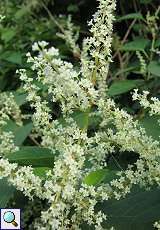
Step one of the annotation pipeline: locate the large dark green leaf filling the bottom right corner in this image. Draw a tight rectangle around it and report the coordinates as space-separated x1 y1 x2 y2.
103 189 160 230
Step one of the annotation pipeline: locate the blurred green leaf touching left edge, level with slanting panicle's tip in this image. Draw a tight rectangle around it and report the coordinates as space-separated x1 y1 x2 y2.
0 51 22 65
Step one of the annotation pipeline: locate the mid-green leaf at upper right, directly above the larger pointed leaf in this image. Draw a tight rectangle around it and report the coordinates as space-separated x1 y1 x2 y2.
121 38 150 51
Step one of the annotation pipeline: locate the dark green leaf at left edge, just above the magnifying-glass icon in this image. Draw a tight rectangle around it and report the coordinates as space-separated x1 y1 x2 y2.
0 179 15 208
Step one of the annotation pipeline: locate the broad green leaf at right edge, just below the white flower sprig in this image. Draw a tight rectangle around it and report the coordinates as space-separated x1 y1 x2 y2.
139 115 160 140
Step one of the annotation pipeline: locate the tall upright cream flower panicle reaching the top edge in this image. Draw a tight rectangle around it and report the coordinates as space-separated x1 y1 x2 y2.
81 0 116 97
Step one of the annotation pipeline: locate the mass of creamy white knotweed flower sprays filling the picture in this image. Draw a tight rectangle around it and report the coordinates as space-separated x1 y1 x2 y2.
0 0 160 230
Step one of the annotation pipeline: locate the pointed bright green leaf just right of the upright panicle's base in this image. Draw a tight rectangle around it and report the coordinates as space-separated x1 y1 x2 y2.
108 80 144 96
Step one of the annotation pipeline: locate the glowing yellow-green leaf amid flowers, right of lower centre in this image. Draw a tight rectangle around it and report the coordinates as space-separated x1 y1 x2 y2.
83 169 116 185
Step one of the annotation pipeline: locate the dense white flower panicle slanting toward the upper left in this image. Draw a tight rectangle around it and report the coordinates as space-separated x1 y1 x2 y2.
21 43 97 113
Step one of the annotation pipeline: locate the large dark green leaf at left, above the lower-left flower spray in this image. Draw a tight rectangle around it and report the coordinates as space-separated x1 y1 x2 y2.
6 146 55 167
